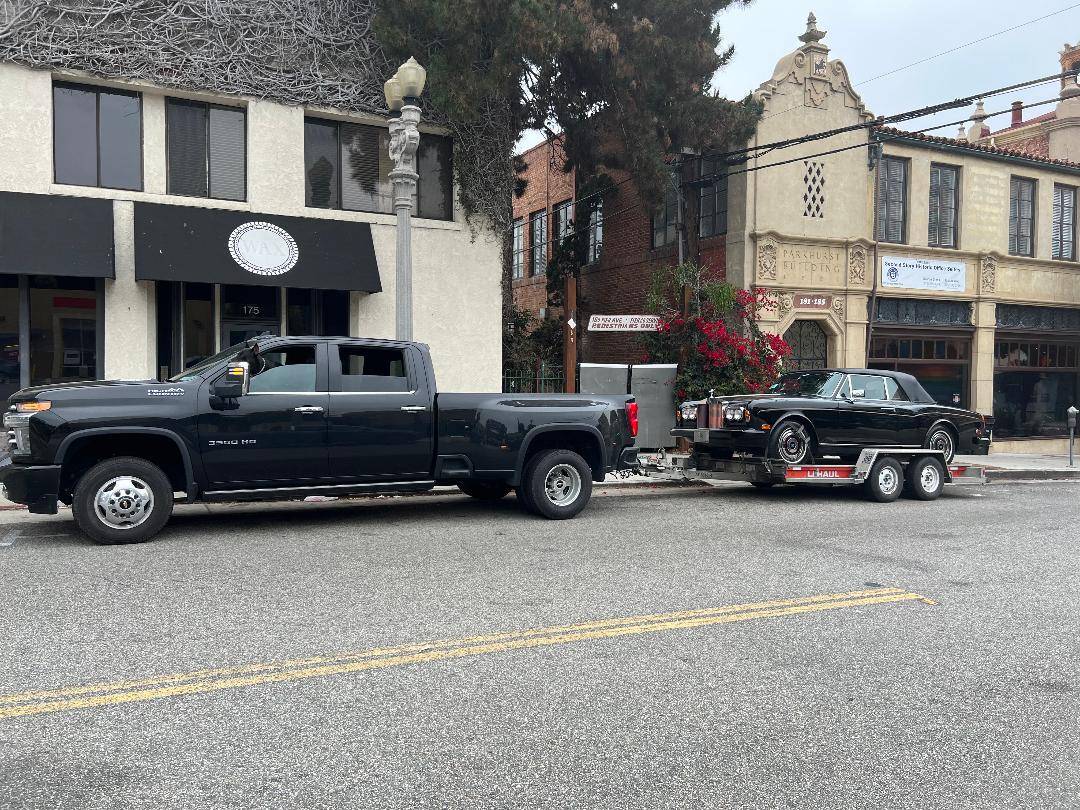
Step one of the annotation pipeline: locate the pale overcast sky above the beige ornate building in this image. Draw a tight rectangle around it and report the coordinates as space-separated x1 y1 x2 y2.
521 0 1080 148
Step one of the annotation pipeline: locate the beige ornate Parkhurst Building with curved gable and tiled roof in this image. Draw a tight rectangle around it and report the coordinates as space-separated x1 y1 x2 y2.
727 15 1080 451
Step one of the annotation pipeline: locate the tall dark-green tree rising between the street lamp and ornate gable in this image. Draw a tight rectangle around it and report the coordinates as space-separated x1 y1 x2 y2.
375 0 760 330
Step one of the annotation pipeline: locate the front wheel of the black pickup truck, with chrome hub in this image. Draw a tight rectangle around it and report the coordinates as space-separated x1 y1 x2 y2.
71 456 173 544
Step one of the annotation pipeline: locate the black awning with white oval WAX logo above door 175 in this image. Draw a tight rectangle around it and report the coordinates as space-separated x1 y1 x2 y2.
135 203 382 293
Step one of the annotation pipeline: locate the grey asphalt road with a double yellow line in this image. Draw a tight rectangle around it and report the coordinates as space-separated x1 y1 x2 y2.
0 483 1080 809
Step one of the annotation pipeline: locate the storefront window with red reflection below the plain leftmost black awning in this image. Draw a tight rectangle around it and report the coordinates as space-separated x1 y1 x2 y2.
29 275 100 386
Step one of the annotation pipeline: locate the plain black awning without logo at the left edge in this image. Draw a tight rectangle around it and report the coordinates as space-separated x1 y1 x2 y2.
0 192 113 279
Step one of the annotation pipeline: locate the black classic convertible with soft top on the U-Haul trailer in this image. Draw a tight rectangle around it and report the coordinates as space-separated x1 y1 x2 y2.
672 368 990 464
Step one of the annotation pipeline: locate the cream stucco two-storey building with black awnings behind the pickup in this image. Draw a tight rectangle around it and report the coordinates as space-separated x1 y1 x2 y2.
0 26 501 406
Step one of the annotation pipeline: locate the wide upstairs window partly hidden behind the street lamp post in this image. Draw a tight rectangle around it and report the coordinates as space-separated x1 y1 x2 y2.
303 118 454 219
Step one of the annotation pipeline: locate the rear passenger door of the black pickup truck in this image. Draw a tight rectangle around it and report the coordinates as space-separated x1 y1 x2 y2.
327 341 435 483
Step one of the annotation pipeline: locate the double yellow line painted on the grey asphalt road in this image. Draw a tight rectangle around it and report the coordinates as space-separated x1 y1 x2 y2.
0 588 934 719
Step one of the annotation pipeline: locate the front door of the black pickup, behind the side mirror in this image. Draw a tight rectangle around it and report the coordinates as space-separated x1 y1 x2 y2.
199 342 329 489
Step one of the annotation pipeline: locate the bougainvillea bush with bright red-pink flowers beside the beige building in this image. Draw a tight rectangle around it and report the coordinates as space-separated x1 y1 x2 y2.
642 262 791 400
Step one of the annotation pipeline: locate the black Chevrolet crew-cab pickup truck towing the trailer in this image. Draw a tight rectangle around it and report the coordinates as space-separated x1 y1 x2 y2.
0 337 637 543
